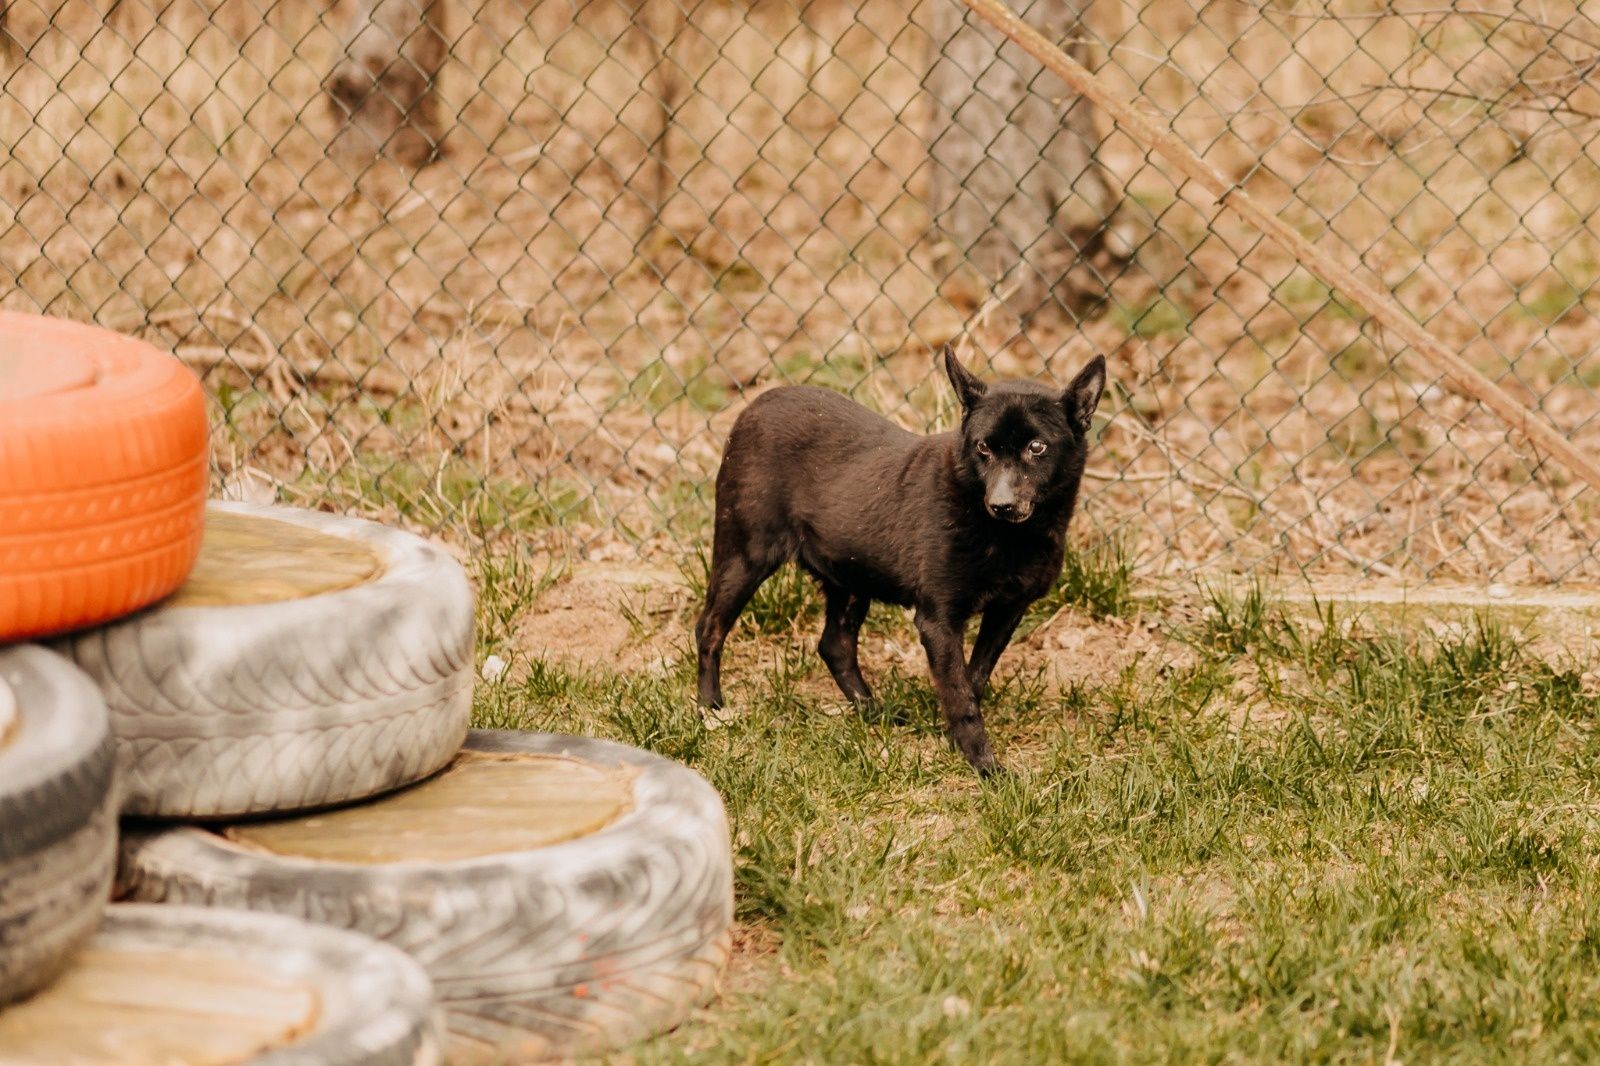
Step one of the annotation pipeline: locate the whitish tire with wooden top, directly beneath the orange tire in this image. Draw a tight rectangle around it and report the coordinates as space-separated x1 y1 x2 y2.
59 504 474 818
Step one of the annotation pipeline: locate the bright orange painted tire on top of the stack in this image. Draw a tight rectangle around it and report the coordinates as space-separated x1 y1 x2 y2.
0 312 208 642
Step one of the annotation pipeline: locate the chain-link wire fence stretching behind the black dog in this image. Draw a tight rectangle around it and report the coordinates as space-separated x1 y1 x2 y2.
0 0 1600 584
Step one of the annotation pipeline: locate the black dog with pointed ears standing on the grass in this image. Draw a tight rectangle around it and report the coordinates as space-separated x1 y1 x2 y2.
694 347 1106 775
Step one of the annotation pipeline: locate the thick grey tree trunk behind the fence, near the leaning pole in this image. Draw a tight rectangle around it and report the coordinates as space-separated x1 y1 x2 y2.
926 0 1118 315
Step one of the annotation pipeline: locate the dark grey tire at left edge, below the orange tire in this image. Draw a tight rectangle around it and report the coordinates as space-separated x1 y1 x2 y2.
0 645 117 1005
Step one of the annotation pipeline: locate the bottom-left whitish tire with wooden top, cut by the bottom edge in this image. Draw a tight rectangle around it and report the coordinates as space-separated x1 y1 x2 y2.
0 904 442 1066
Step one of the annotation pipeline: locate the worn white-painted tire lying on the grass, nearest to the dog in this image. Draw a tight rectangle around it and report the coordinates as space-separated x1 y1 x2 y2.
122 730 733 1063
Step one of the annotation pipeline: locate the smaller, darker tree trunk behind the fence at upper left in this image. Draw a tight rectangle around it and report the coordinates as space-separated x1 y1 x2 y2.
328 0 450 166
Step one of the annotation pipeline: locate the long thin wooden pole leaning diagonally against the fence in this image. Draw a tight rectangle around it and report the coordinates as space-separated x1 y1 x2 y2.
952 0 1600 490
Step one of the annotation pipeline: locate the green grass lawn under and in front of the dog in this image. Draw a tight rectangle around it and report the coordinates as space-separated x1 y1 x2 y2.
477 567 1600 1063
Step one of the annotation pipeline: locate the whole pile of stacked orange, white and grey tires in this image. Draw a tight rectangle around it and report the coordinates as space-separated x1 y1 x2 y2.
0 314 733 1064
